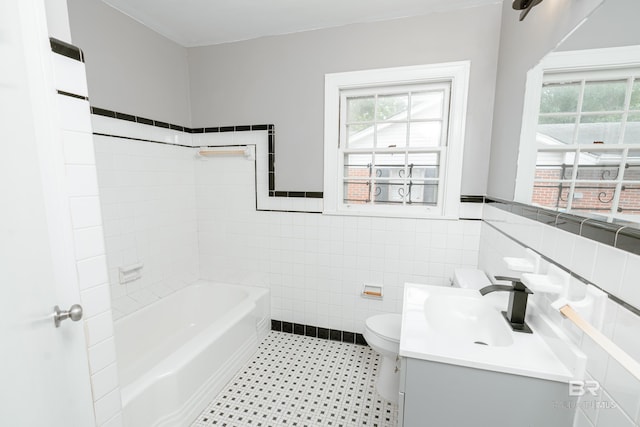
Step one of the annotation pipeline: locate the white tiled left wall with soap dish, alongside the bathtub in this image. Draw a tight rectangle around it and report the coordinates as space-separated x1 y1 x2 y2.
94 135 198 319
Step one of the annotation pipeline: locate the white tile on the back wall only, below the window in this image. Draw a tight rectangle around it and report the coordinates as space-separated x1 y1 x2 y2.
195 157 480 332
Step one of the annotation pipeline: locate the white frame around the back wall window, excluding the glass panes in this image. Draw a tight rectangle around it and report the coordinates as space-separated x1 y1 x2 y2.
323 61 471 219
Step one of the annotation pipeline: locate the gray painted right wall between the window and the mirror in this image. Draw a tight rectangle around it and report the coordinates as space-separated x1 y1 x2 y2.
487 0 604 200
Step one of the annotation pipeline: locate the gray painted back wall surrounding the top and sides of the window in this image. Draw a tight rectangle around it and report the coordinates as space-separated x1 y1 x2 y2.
188 0 501 194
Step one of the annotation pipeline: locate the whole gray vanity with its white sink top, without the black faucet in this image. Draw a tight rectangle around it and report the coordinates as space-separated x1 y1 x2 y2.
399 283 586 427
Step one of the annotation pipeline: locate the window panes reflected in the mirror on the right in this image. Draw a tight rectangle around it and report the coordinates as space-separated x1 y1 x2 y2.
530 53 640 220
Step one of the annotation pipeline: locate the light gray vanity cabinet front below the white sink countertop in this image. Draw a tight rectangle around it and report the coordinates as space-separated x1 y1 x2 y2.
398 357 577 427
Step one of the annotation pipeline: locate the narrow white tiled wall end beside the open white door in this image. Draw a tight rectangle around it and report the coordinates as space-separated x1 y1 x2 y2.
52 54 122 427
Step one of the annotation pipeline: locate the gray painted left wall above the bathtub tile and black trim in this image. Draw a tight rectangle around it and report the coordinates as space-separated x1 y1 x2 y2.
68 0 191 126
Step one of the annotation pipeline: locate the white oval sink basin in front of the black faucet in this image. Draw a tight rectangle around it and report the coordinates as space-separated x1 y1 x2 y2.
424 295 513 346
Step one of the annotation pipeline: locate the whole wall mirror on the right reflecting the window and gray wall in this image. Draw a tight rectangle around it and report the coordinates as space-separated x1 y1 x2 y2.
515 0 640 223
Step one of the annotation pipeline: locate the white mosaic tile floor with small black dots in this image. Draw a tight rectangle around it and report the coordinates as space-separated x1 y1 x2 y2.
191 331 398 427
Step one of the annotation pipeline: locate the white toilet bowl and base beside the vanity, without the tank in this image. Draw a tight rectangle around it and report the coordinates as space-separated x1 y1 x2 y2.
363 314 402 403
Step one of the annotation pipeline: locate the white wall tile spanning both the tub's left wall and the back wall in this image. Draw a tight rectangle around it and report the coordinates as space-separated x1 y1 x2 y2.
93 115 480 332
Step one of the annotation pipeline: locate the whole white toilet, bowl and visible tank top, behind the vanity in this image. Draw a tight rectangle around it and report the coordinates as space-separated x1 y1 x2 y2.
363 268 491 403
